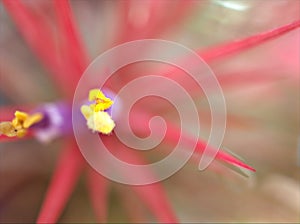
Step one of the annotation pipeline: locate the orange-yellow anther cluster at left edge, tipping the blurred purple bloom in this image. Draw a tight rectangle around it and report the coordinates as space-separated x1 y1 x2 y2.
0 111 43 138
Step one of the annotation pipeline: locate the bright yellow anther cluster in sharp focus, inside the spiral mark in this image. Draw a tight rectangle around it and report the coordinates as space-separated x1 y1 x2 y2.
80 89 115 134
